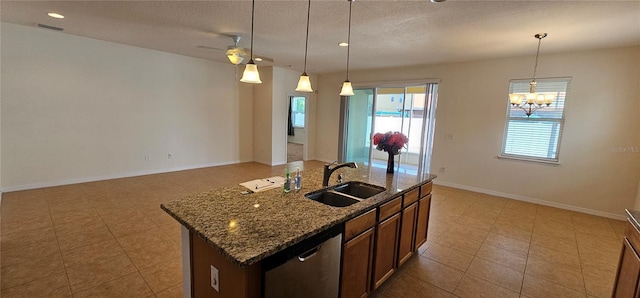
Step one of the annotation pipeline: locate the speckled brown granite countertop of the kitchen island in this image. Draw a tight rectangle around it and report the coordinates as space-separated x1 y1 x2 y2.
161 164 436 267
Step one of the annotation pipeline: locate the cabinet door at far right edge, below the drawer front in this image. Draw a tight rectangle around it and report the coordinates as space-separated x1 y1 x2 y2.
613 238 640 298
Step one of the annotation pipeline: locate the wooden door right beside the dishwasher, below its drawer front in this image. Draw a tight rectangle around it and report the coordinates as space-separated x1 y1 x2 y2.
340 228 374 298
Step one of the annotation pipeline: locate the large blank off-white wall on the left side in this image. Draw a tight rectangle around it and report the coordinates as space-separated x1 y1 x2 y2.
0 23 253 191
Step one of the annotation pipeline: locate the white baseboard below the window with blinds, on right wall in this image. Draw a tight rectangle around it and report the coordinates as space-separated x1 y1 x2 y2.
433 179 627 220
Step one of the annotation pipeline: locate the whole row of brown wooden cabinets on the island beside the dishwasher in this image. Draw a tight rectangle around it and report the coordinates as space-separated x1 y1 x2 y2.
340 182 431 298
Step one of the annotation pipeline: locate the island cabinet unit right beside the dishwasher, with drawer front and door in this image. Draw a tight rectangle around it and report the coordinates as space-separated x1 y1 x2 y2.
340 209 376 298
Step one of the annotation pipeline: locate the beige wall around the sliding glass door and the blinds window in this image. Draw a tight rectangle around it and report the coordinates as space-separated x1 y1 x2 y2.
316 48 640 216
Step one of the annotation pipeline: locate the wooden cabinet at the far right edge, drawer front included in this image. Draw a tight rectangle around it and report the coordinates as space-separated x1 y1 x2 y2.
612 222 640 298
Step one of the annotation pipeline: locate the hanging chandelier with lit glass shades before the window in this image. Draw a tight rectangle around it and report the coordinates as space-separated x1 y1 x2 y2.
509 33 555 118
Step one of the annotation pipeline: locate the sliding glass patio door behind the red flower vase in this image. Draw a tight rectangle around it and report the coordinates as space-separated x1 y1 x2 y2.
339 83 438 175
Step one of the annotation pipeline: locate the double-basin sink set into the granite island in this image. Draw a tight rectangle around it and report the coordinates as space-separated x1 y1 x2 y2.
305 181 386 207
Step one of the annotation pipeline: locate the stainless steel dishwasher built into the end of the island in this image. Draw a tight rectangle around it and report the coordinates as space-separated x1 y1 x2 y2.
263 227 342 298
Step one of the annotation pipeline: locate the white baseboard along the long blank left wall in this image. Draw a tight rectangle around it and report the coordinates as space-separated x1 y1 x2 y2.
2 160 252 192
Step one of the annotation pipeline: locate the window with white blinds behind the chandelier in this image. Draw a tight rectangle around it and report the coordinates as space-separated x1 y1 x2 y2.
501 78 571 162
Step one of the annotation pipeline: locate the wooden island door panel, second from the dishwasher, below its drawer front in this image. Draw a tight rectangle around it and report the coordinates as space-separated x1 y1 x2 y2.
373 213 400 290
